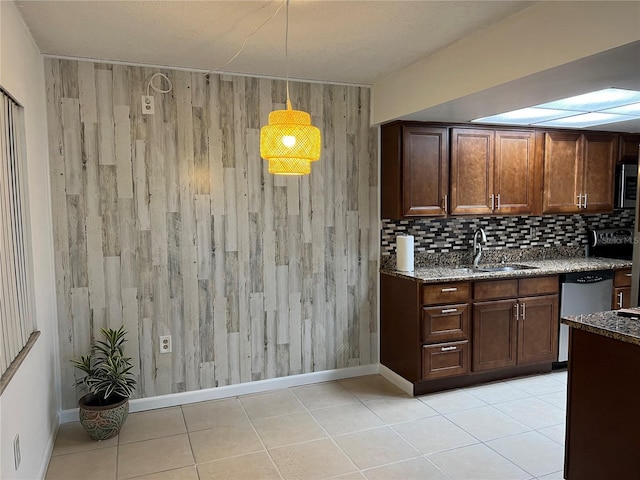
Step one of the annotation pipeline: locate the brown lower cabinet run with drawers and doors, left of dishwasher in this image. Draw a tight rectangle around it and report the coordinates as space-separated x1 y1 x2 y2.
380 273 559 395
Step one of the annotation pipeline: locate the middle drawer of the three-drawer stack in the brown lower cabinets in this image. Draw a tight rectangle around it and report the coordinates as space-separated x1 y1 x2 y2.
422 303 469 343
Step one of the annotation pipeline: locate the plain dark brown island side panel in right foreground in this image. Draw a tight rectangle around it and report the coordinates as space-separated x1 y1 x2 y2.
564 328 640 480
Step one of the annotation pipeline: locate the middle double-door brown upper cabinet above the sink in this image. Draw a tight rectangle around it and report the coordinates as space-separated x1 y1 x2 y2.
450 128 539 215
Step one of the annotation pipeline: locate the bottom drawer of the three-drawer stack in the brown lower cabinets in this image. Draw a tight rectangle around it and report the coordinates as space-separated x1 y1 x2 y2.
422 341 469 380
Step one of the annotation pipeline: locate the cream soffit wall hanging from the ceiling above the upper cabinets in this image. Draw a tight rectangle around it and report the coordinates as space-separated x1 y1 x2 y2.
371 1 640 125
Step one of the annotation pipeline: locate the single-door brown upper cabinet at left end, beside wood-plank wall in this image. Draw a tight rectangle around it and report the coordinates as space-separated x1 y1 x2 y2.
381 122 449 219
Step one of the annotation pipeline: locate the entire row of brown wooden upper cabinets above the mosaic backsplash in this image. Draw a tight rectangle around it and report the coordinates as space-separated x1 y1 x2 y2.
381 121 624 220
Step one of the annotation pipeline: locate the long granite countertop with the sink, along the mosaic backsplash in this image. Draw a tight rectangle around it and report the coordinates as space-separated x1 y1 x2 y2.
380 257 632 283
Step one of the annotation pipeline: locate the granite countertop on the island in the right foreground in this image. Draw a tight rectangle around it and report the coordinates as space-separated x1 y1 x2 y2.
560 309 640 346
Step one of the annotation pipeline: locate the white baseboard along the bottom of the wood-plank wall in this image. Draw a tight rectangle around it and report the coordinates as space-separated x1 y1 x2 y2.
59 363 380 424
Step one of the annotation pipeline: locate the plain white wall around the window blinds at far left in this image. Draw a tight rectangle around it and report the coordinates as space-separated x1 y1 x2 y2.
0 1 60 480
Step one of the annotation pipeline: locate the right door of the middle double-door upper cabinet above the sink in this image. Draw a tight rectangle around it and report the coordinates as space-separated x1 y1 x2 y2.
493 130 539 215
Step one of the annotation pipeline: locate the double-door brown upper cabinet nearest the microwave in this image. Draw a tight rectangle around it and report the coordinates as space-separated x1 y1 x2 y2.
543 132 618 213
